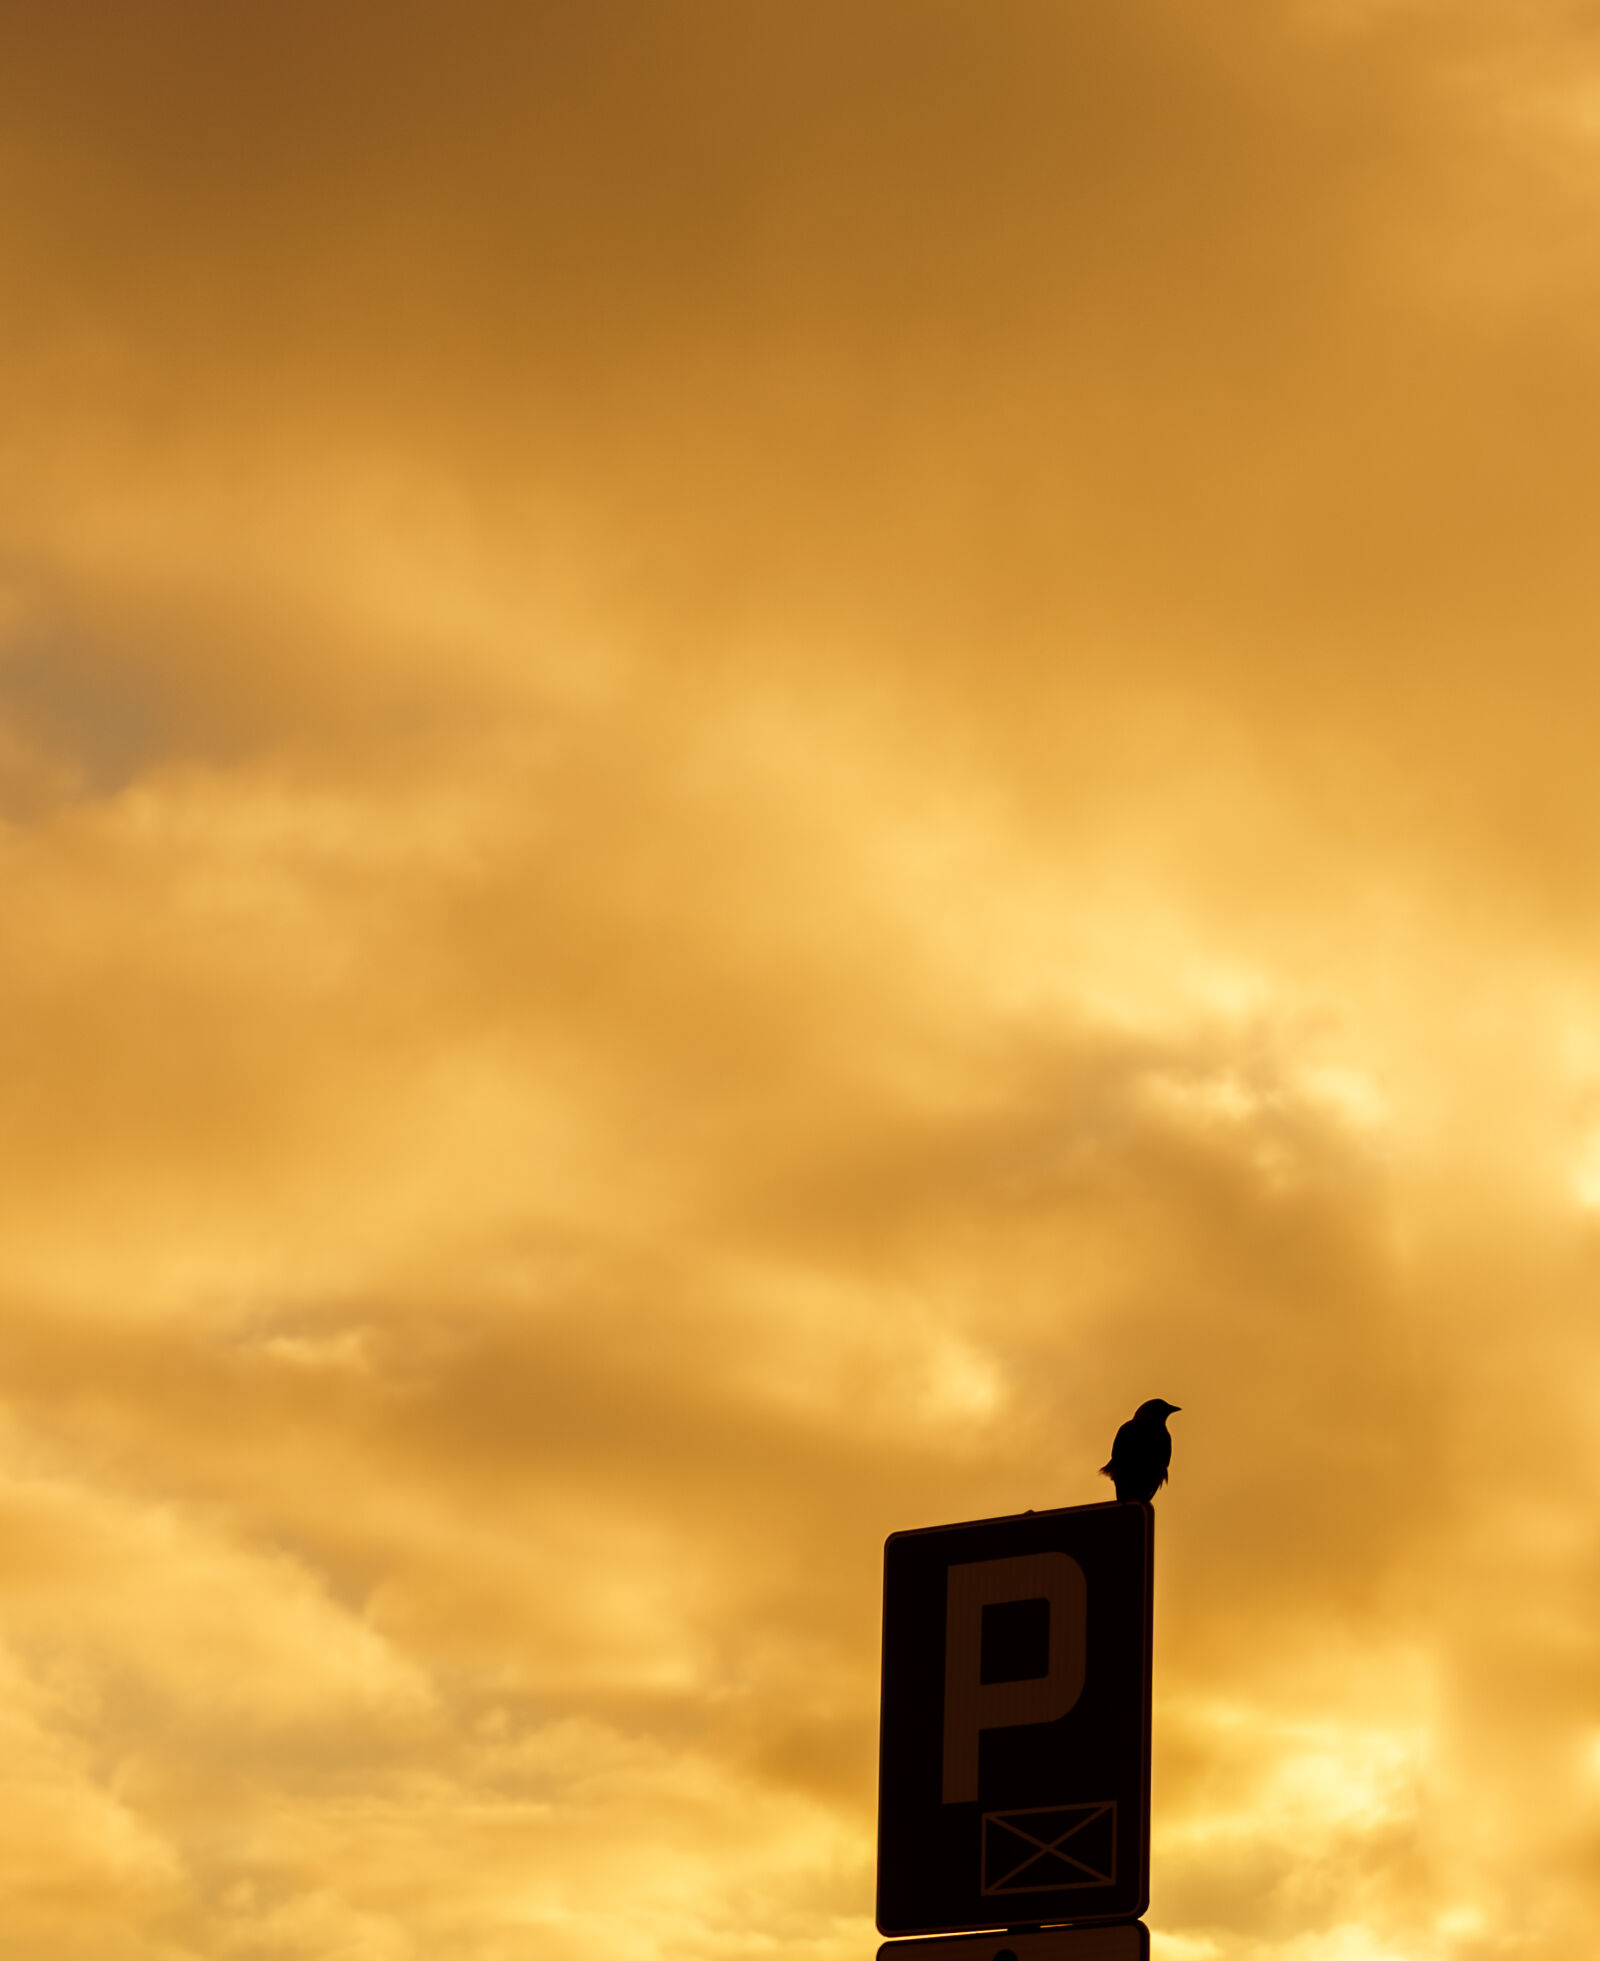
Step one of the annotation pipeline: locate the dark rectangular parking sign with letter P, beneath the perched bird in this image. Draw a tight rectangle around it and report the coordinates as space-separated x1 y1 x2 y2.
878 1504 1155 1929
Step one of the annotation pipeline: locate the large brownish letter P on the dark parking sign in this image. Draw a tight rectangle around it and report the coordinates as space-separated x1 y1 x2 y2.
945 1553 1088 1804
